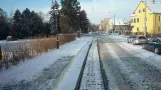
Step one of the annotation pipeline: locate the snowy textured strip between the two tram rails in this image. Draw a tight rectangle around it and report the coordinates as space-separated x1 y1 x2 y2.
80 40 104 90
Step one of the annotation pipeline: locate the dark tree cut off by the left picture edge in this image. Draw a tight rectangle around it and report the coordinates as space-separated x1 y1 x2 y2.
0 8 10 39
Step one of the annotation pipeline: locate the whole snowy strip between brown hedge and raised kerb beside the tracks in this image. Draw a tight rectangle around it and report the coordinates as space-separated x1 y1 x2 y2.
0 37 92 90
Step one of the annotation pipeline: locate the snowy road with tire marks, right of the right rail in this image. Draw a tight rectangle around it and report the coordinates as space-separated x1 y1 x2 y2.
99 35 161 90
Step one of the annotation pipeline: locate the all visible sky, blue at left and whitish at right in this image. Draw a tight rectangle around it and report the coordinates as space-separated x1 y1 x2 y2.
0 0 155 24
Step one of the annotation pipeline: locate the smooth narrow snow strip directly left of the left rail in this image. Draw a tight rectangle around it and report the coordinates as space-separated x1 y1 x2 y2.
54 42 91 90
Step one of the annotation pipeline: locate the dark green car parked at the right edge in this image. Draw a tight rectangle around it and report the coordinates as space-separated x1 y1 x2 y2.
143 38 161 54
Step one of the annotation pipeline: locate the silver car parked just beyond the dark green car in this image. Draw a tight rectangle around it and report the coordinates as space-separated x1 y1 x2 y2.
127 36 147 45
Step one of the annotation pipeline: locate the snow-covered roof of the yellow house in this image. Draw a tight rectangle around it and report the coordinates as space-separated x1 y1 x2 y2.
147 1 161 13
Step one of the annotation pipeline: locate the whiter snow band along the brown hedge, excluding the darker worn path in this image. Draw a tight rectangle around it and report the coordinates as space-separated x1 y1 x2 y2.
0 37 92 84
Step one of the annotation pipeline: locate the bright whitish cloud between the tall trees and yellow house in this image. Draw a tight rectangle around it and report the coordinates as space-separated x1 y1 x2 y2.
81 0 140 24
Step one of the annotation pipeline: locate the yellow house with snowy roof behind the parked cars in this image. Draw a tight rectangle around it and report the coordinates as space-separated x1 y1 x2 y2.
131 0 161 35
